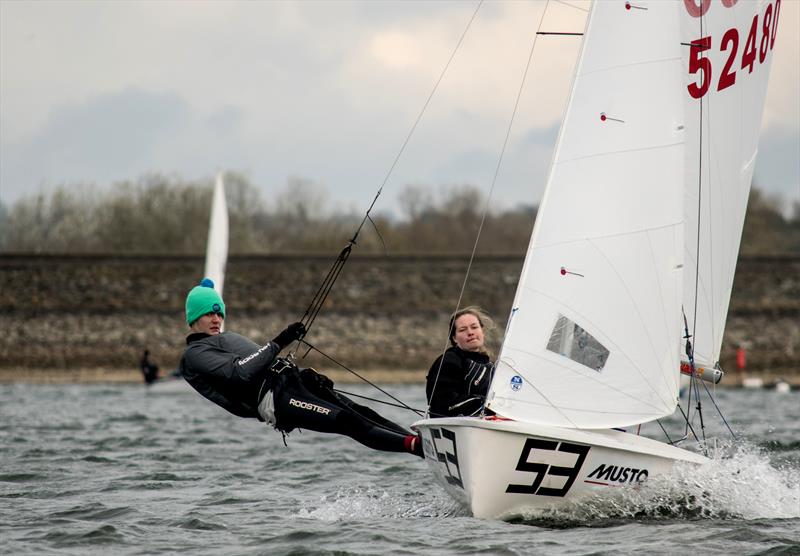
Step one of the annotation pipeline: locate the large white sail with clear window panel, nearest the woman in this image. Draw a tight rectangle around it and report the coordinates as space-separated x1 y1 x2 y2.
487 0 685 428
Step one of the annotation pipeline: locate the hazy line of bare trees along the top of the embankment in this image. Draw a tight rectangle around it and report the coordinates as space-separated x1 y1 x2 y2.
0 173 800 255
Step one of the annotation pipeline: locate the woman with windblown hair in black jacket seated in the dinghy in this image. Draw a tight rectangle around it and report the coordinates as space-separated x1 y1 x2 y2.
425 307 494 417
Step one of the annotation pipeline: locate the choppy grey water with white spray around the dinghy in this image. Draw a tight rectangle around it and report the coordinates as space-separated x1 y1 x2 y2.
0 385 800 555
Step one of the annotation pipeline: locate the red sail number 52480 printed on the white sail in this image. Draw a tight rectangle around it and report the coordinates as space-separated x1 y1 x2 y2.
684 0 781 98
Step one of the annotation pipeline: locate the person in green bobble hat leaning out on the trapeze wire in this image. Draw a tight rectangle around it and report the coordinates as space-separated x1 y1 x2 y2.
180 278 424 457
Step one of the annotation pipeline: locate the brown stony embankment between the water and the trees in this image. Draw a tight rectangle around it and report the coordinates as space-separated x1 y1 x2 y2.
0 255 800 380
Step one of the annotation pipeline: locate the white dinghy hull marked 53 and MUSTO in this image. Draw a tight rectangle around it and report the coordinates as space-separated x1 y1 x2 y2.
413 417 710 519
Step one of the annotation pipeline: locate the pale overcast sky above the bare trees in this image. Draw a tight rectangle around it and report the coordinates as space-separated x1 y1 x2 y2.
0 0 800 217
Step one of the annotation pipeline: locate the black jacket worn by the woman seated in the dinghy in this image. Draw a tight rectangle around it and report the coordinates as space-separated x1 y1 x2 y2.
425 346 493 417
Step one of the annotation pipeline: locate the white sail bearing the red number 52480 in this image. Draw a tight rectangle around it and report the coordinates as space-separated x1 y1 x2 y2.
681 0 785 366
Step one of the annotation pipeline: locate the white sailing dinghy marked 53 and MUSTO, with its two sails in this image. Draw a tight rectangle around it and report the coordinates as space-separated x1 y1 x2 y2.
412 0 781 519
